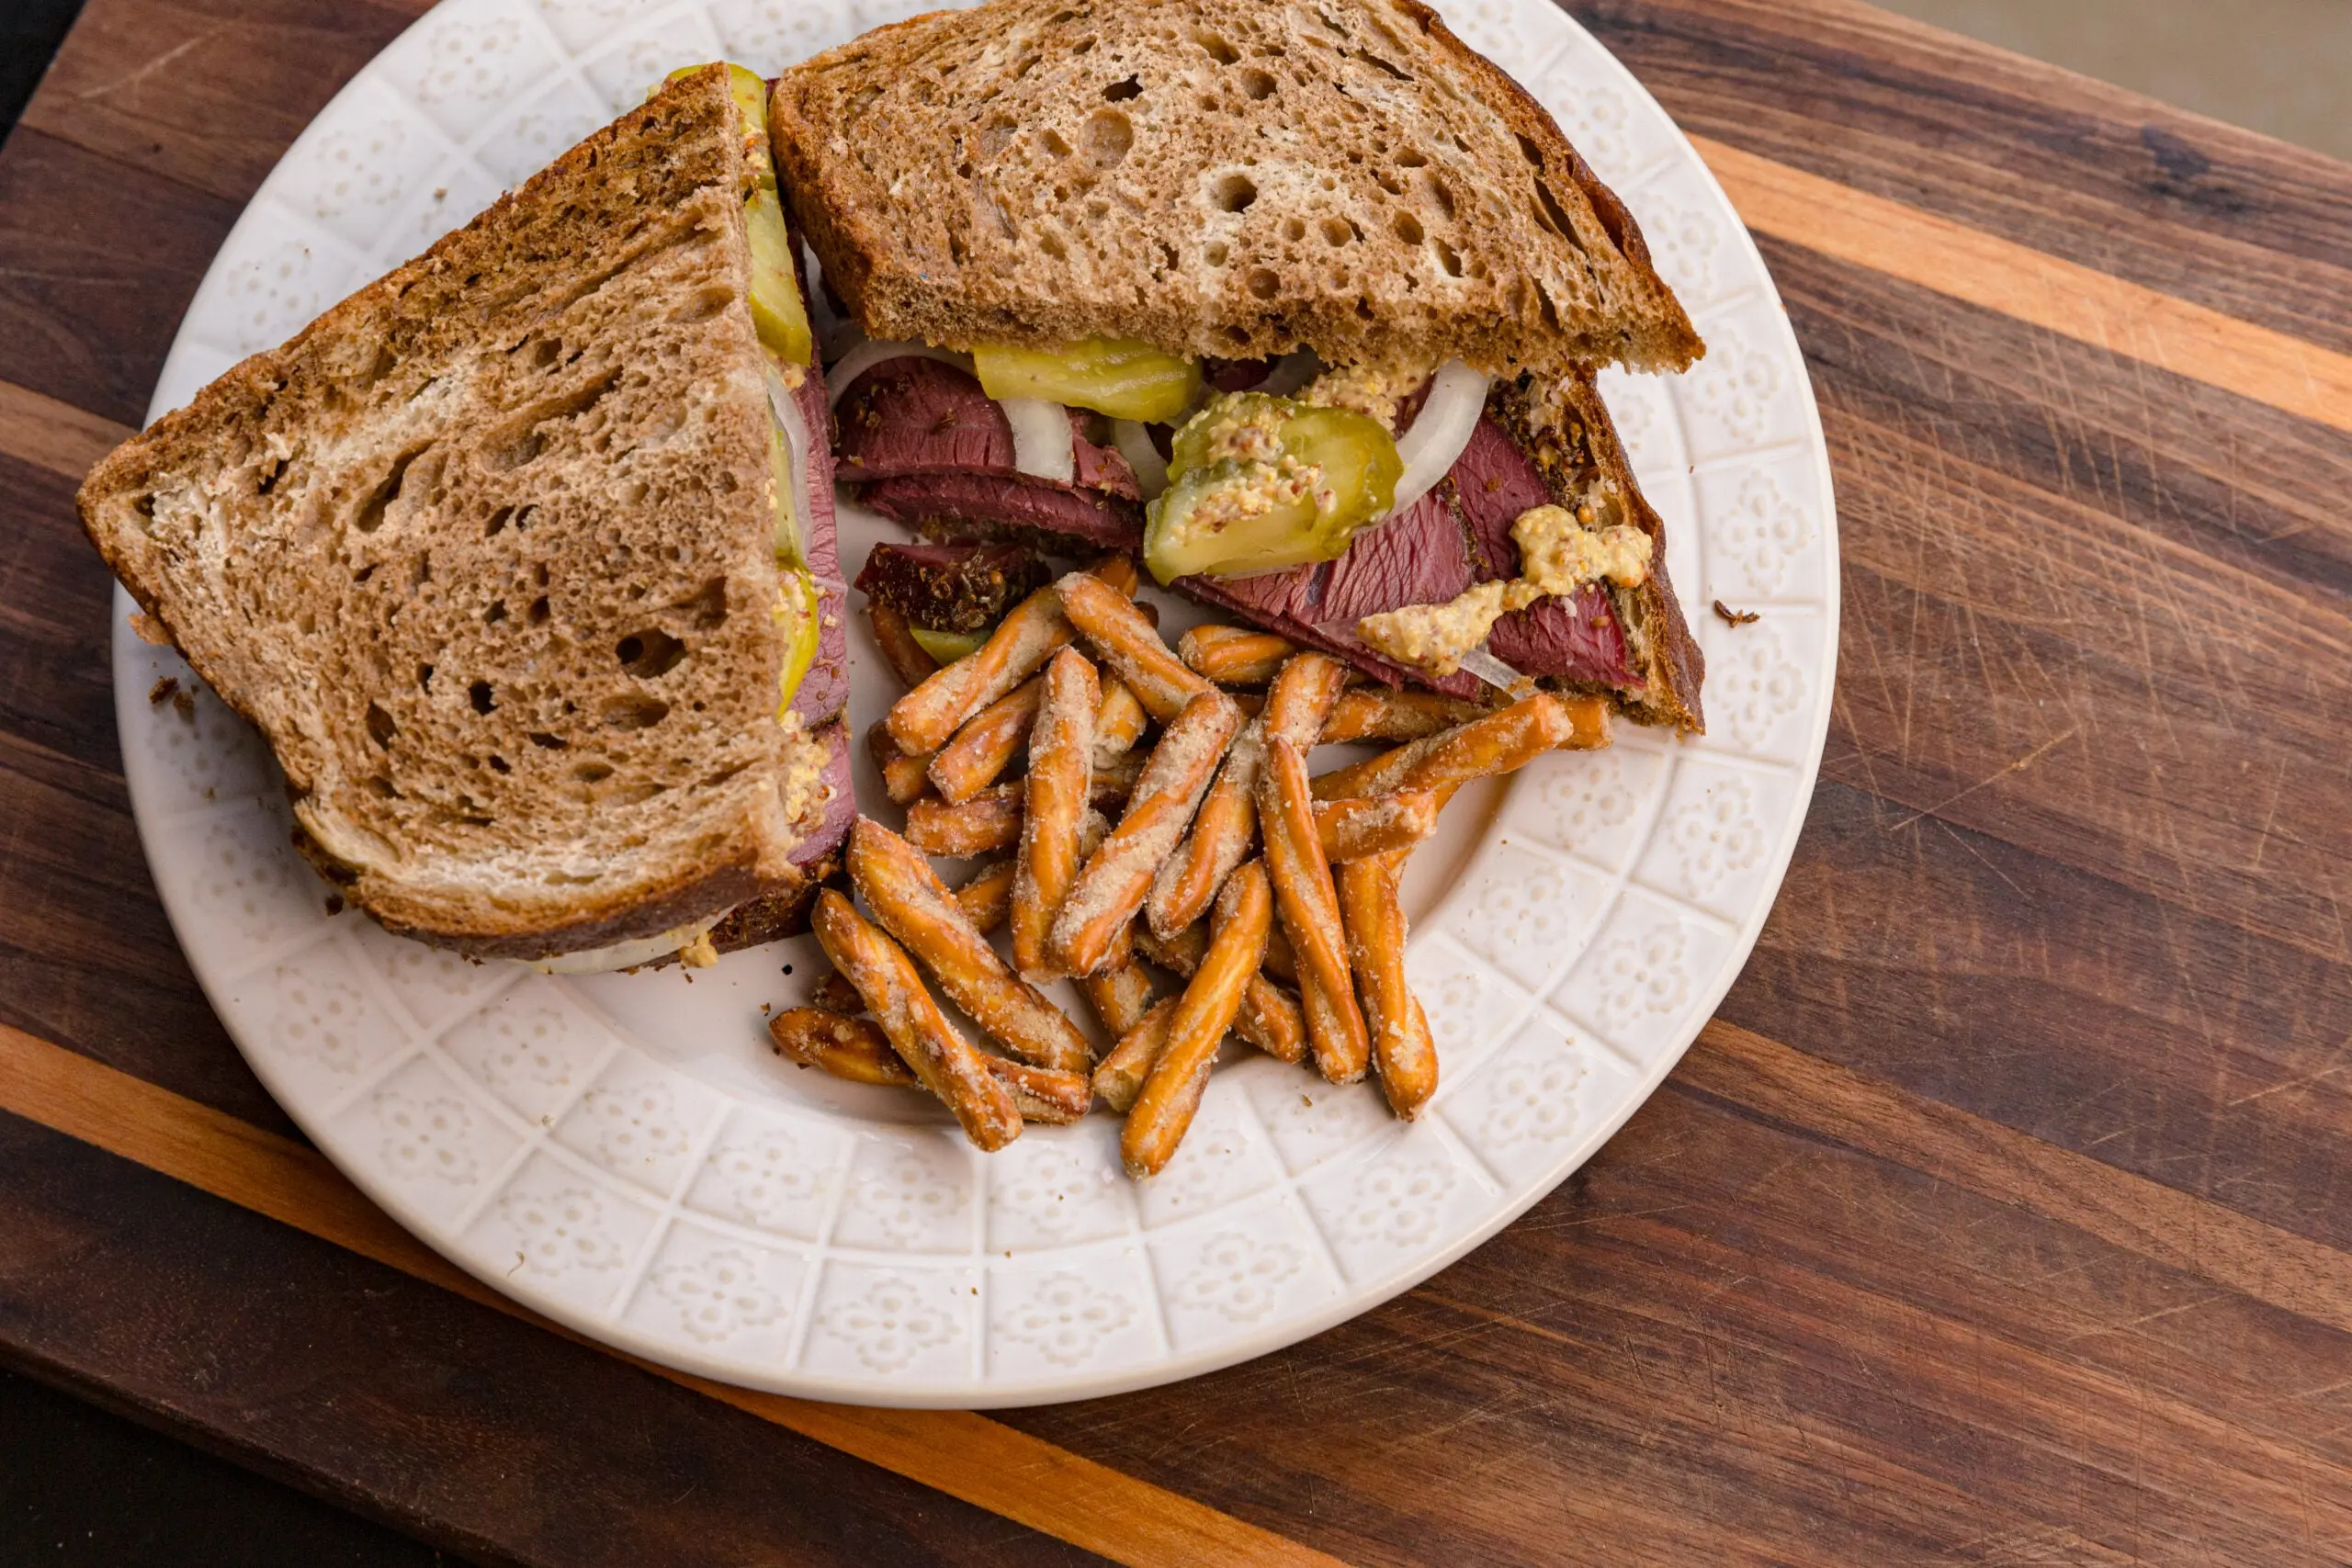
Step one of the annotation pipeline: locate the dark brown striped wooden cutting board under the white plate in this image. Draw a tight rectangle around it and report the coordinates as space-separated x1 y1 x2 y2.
0 0 2352 1568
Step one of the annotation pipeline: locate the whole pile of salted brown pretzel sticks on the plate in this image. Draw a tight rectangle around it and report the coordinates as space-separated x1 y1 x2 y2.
769 558 1609 1178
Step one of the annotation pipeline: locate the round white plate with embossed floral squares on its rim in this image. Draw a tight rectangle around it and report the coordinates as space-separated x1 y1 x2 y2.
115 0 1837 1405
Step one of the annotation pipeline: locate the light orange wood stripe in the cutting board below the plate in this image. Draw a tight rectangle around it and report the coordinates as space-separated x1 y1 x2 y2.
0 1025 1336 1568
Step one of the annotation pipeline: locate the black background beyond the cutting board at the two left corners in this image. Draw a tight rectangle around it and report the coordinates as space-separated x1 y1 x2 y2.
0 0 454 1568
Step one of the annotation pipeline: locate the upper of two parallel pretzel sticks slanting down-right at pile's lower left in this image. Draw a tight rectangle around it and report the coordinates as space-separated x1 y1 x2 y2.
849 816 1093 1072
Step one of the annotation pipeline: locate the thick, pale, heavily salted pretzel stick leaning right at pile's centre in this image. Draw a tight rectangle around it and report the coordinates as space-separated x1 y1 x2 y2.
1046 682 1242 976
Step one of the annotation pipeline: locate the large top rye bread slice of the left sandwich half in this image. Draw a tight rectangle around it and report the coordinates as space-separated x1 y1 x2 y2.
80 68 826 957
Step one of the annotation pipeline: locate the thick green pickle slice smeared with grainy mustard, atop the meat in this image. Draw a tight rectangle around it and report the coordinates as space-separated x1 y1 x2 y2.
1143 392 1404 583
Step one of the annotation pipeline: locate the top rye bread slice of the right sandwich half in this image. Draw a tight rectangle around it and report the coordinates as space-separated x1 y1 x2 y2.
769 0 1702 374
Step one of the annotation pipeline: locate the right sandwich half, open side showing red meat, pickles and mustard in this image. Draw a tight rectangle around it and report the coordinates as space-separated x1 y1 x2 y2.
769 0 1702 731
